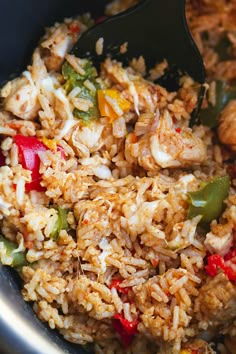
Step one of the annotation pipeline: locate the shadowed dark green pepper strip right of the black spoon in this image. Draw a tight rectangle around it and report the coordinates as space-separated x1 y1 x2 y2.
200 80 236 128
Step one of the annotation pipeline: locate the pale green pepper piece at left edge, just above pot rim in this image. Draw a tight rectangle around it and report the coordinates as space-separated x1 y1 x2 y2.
0 235 27 267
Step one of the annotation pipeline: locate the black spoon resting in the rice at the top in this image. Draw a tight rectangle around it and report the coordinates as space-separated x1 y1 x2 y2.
72 0 205 86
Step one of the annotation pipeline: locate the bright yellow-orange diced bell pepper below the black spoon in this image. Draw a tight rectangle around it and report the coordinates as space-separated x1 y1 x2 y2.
97 89 131 120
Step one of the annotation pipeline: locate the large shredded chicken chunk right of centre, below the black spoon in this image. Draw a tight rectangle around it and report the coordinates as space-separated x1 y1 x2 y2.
125 110 206 171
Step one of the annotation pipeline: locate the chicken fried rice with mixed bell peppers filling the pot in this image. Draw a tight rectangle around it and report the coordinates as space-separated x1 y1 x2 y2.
0 0 236 354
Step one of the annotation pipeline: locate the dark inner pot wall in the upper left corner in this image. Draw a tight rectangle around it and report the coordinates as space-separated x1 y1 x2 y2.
0 0 109 83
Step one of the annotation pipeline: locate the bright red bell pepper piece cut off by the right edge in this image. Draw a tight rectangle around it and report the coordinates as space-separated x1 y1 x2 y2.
206 248 236 281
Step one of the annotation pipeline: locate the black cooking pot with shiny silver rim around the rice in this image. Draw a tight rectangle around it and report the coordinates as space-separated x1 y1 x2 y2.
0 0 106 354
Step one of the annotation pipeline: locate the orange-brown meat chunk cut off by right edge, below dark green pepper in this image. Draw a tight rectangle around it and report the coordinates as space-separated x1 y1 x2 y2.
218 100 236 151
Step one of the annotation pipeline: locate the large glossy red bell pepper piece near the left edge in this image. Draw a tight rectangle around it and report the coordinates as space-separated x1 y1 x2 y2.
14 135 48 192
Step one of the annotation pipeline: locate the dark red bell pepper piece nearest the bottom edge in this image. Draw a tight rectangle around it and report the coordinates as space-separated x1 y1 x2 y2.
113 313 139 348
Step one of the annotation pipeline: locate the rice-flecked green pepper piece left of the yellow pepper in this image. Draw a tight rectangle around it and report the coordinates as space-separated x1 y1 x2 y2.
62 59 100 122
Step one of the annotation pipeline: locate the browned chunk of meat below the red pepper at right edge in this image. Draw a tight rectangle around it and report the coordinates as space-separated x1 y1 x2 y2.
196 273 236 326
